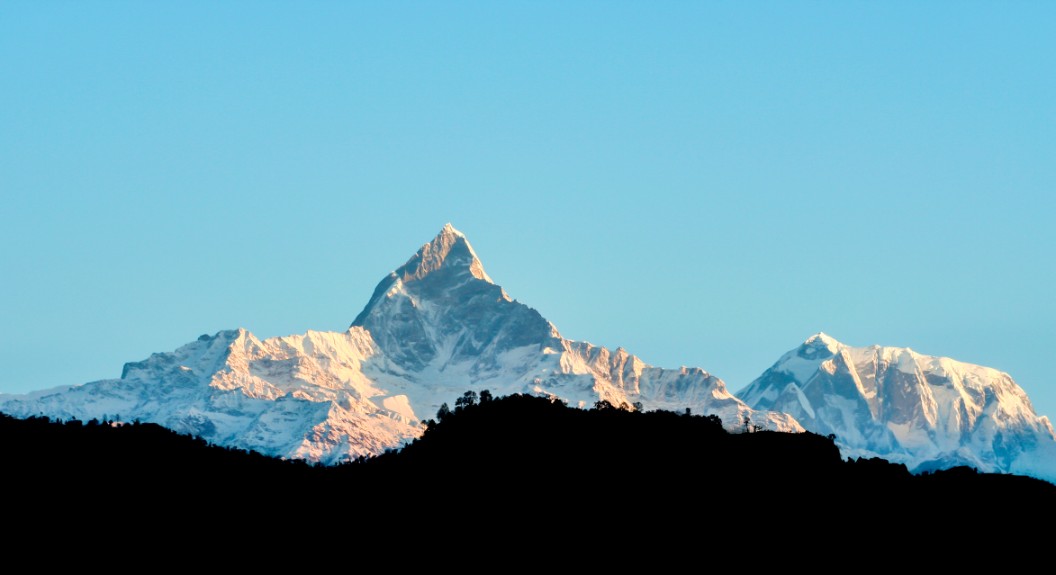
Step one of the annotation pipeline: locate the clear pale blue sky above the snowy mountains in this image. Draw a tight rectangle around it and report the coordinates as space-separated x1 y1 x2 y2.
0 0 1056 417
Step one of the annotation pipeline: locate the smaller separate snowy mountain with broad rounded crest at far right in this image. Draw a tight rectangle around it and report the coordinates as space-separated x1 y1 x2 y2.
737 333 1056 481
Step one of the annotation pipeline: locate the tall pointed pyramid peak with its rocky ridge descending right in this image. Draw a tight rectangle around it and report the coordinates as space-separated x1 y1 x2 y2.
353 224 799 429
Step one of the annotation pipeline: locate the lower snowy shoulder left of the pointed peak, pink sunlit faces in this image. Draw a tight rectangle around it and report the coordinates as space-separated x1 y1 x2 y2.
0 329 419 461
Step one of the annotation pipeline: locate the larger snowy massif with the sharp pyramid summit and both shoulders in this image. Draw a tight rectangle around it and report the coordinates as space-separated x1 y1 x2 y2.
0 224 803 463
